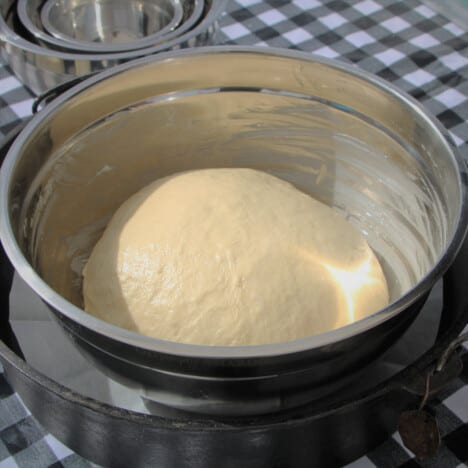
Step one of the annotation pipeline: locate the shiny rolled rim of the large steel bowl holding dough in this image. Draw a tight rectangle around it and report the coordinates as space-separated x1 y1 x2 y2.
0 46 468 360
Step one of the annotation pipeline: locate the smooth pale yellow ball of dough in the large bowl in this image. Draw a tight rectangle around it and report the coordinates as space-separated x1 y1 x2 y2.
83 169 388 345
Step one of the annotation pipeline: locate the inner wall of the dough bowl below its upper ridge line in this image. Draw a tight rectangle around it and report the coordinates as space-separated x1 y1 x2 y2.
18 89 447 306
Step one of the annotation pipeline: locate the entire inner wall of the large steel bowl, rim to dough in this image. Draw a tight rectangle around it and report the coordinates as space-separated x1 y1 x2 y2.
6 52 461 330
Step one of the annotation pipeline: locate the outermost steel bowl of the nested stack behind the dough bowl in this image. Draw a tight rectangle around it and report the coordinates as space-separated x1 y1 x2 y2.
0 0 221 94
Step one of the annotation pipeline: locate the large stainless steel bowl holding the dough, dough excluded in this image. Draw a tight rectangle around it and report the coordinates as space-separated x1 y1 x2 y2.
0 47 468 415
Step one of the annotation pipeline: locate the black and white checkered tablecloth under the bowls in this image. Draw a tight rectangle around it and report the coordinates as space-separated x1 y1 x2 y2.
0 0 468 468
